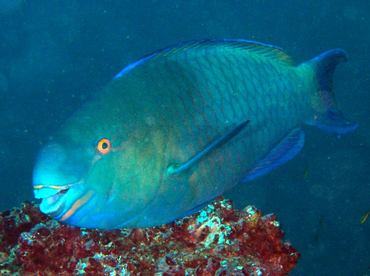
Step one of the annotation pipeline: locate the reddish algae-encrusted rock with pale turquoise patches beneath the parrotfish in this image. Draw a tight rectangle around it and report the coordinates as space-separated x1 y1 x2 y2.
0 198 300 276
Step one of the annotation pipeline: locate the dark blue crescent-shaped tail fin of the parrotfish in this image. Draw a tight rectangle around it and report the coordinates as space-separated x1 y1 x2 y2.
307 49 358 135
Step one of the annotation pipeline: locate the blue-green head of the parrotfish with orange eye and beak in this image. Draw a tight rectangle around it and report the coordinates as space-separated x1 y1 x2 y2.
33 91 169 229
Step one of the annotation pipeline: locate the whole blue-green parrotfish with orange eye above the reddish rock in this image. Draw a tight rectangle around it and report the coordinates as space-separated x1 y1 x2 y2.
33 39 357 229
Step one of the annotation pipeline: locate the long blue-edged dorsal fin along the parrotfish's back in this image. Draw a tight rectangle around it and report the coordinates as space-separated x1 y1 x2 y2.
115 39 293 78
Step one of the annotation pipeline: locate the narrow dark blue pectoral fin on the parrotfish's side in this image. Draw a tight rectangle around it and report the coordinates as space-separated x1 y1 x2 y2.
167 121 249 174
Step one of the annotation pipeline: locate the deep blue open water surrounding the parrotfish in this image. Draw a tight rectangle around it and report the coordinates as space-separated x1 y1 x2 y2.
0 0 370 275
